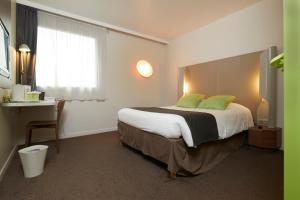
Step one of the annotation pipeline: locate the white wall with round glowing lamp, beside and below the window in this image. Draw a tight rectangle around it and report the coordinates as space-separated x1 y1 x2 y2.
18 31 166 142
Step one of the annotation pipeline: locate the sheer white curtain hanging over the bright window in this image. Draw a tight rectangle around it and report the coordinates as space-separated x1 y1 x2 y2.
36 11 106 100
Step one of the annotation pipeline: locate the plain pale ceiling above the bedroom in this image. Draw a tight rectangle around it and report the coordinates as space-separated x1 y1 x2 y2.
30 0 261 40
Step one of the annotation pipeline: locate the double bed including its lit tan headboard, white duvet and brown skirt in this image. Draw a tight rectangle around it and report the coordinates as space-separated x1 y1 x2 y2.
118 52 261 176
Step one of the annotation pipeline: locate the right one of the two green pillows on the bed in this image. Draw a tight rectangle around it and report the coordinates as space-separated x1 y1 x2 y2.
198 95 235 110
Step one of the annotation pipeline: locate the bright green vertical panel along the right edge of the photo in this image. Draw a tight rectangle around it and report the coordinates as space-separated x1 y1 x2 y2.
284 0 300 200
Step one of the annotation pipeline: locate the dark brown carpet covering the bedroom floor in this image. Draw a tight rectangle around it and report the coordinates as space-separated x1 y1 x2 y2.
0 132 283 200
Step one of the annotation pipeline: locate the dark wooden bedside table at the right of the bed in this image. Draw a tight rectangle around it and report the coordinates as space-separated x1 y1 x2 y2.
248 126 281 149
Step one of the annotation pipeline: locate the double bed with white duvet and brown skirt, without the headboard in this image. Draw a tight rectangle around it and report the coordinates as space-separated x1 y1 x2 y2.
118 103 253 176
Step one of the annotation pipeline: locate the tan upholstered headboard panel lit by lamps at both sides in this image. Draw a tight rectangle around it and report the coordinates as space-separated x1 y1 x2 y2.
184 52 261 120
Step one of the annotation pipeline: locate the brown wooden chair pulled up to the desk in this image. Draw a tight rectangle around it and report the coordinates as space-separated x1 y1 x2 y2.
26 100 65 153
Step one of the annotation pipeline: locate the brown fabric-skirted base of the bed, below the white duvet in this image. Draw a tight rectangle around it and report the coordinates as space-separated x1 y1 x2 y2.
118 121 245 178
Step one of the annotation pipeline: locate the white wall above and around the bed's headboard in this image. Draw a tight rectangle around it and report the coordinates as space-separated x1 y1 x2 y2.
164 0 283 126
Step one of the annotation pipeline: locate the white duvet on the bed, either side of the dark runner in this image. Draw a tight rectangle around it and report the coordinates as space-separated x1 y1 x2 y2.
118 103 253 147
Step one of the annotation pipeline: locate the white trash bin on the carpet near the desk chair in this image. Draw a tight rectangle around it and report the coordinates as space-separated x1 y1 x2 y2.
18 145 48 178
